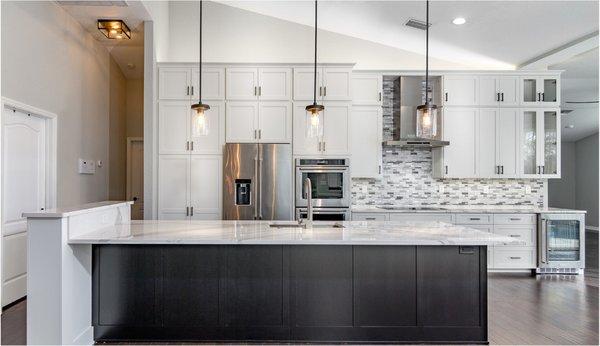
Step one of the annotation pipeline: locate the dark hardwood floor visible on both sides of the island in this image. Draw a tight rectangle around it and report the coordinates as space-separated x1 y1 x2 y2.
0 233 599 345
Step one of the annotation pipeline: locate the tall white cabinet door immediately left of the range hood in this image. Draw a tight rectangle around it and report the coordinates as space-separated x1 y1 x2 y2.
350 106 382 178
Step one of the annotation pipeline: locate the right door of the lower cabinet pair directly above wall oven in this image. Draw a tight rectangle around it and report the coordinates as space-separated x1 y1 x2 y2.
322 102 351 155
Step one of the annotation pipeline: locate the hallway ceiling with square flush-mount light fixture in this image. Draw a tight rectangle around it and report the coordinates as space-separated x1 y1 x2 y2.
58 1 151 79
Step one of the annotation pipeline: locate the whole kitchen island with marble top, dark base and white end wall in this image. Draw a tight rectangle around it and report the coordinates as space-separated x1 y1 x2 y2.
26 203 519 344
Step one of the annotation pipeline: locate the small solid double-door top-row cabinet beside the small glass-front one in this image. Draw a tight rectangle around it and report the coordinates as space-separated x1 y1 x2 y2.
479 76 519 107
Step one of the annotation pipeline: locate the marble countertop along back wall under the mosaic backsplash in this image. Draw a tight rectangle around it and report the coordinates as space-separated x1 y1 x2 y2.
351 205 586 214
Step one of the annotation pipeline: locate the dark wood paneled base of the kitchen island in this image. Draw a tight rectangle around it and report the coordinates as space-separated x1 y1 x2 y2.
92 245 488 344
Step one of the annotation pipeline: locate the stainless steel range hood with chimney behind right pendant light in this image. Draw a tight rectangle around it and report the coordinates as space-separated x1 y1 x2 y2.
383 76 450 148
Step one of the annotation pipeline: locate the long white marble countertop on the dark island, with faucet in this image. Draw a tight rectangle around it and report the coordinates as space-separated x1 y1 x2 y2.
69 220 523 246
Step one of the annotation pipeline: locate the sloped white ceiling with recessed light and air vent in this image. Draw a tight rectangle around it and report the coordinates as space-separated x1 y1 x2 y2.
218 0 598 69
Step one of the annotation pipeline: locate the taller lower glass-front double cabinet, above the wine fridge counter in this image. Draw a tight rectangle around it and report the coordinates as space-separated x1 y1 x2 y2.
520 108 560 178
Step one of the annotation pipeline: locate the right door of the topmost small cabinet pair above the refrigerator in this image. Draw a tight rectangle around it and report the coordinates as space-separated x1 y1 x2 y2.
258 67 292 101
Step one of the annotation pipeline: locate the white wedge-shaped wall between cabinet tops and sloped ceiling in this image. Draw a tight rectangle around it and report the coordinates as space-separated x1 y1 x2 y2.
164 1 467 70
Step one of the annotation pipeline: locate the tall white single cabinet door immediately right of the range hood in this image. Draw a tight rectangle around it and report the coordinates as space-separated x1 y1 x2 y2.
444 108 479 178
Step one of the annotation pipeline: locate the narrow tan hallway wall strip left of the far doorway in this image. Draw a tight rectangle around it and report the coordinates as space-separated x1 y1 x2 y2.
108 56 127 200
